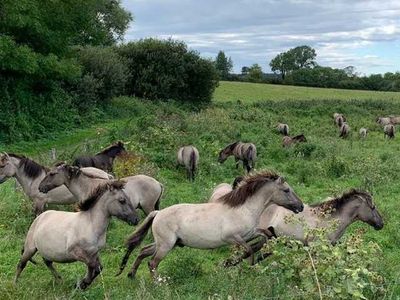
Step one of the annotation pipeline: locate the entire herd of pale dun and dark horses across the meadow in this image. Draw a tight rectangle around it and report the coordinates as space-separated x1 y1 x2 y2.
0 114 390 289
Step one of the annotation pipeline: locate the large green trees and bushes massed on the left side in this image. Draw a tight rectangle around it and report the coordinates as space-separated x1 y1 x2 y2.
0 0 219 144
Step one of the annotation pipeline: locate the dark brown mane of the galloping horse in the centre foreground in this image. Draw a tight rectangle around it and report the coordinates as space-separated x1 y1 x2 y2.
219 171 279 207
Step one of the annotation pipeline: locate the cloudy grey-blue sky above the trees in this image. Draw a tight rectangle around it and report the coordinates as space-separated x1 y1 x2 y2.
122 0 400 74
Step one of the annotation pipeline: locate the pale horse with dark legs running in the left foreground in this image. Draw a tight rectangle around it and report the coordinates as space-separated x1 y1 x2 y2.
14 181 139 289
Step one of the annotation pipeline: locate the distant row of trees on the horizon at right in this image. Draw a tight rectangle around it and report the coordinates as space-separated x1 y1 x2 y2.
216 45 400 92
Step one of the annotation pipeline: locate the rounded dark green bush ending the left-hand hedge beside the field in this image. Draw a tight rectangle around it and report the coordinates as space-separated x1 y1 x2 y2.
118 39 218 102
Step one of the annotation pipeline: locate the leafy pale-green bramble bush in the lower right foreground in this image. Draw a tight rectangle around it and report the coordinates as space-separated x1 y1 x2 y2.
262 220 386 299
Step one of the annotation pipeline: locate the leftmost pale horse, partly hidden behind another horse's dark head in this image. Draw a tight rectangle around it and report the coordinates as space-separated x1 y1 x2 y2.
0 153 109 215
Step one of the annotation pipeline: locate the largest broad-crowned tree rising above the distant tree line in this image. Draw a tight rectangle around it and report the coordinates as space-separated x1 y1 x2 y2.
269 46 317 80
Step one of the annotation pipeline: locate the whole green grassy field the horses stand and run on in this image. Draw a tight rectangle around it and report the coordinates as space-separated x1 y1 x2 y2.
0 82 400 299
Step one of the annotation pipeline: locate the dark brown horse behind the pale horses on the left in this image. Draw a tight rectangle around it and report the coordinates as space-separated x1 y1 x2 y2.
72 142 126 172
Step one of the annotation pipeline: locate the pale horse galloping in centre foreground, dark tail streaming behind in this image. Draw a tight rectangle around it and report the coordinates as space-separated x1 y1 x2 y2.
117 172 303 278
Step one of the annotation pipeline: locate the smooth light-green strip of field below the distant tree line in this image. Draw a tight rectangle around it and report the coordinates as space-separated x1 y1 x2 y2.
214 81 400 103
